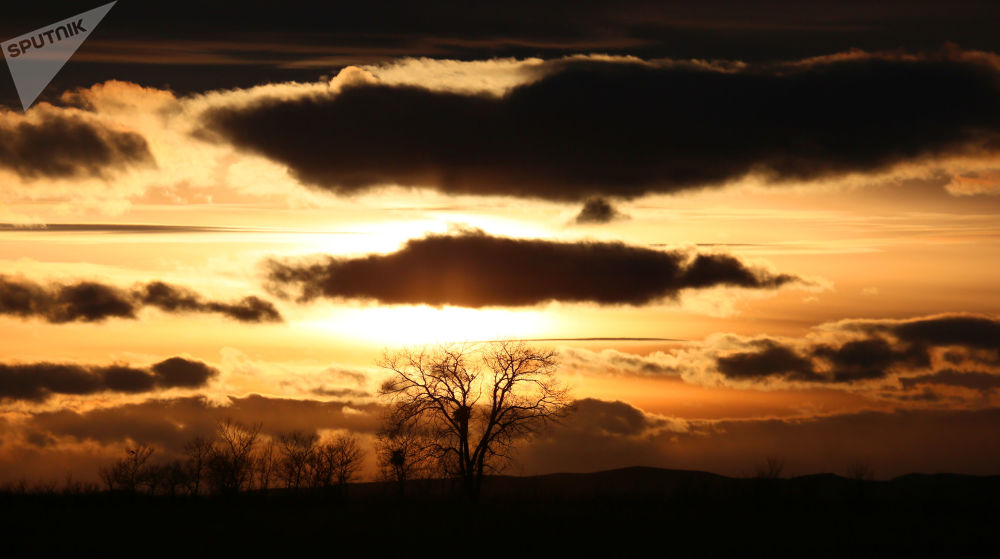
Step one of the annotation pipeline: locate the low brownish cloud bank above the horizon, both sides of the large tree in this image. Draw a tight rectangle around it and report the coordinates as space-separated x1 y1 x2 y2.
7 395 1000 480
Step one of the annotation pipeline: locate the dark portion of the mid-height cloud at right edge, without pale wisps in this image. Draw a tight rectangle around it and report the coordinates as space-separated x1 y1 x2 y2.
715 315 1000 388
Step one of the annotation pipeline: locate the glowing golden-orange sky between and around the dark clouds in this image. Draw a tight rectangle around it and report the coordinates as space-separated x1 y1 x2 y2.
0 51 1000 479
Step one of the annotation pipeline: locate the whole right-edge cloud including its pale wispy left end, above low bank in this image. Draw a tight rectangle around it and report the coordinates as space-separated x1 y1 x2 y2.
560 313 1000 396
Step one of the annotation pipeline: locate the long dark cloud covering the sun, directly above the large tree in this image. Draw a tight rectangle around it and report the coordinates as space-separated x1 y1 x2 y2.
268 231 796 307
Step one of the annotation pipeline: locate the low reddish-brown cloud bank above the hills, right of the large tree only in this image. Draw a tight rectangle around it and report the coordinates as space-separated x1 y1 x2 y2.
518 399 1000 478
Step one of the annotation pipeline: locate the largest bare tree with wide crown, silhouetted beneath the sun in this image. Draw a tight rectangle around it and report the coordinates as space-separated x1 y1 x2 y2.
379 341 569 500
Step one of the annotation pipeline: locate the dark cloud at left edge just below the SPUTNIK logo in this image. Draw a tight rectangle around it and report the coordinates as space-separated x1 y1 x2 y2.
0 110 153 179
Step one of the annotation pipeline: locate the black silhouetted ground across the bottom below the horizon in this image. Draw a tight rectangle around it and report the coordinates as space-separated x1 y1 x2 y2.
0 468 1000 558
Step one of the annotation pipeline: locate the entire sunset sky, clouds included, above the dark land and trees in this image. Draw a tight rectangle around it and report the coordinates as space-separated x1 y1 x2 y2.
0 0 1000 481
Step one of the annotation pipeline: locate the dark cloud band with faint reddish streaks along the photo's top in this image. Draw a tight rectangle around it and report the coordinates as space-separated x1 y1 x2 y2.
0 0 1000 106
